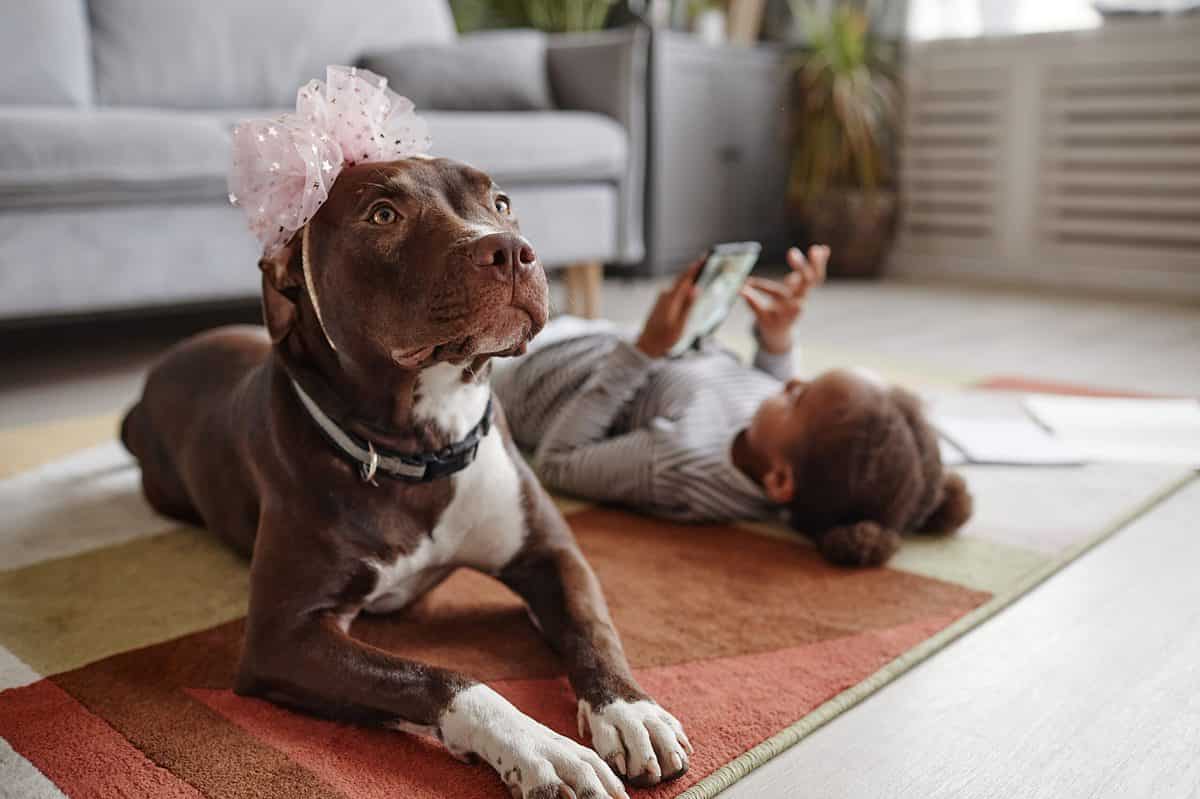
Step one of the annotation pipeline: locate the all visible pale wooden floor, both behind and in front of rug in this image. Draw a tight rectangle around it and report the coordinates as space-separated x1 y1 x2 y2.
0 272 1200 799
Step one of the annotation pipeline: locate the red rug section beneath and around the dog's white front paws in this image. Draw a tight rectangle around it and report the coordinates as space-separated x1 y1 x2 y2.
191 615 955 799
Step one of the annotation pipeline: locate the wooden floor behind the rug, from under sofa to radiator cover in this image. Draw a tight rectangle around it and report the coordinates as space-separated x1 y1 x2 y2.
0 280 1200 427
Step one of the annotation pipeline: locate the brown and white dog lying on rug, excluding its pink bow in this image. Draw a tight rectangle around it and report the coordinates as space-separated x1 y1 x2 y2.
121 157 691 799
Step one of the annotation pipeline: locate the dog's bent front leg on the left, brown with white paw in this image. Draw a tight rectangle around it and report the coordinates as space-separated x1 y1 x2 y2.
238 539 628 799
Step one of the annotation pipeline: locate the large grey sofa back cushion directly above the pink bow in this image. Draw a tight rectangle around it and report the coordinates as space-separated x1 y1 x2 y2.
90 0 456 108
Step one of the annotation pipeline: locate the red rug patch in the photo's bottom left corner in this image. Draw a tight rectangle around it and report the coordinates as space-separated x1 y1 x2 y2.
0 680 203 799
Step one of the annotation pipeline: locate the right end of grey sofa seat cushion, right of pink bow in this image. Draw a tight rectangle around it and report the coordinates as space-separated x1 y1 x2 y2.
422 112 628 184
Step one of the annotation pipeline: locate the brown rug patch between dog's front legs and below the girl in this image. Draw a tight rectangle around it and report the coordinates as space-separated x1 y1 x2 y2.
353 509 988 680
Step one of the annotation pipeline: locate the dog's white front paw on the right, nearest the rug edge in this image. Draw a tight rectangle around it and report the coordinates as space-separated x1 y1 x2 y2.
578 699 692 787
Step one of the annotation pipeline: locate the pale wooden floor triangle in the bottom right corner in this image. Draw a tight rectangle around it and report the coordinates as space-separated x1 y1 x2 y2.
721 481 1200 799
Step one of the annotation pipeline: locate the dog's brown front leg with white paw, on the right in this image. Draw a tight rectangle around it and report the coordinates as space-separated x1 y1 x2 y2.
500 523 691 787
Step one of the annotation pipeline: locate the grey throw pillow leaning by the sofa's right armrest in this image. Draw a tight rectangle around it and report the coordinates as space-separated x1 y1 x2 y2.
361 30 554 110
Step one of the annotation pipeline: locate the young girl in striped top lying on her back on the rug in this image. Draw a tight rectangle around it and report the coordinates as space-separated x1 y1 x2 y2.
492 247 971 565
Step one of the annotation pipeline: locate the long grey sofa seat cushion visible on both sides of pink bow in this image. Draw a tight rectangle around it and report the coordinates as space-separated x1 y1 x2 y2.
0 106 626 209
